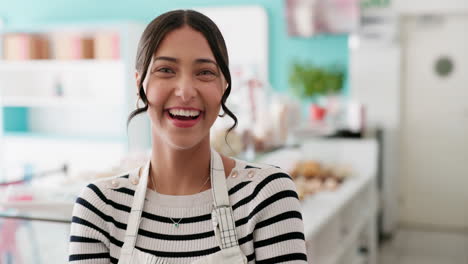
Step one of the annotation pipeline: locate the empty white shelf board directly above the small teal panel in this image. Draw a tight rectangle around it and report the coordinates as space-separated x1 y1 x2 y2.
0 96 123 108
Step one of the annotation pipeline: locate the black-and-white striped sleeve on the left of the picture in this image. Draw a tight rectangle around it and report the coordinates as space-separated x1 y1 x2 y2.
69 184 110 264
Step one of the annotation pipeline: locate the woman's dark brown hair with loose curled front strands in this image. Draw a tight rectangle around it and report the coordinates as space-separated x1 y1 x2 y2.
127 10 237 131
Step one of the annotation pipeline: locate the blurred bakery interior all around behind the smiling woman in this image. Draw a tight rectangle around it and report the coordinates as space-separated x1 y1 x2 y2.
0 0 468 264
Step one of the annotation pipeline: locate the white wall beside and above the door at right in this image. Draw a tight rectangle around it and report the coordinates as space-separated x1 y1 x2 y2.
350 0 468 233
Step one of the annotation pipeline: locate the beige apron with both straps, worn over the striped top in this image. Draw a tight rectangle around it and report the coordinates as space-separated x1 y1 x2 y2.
118 150 247 264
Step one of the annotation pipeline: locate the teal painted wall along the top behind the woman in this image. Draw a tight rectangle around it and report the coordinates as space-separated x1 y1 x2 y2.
0 0 348 93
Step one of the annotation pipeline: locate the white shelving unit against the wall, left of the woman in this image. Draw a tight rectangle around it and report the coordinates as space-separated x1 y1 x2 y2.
0 22 150 181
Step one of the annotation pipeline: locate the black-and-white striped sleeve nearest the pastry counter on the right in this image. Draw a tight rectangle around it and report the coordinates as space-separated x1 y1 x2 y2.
251 170 307 264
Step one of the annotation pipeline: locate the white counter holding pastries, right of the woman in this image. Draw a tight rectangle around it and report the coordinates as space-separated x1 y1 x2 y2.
260 139 378 264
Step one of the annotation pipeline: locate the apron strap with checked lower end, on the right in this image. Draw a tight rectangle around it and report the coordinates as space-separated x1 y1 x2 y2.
211 150 239 249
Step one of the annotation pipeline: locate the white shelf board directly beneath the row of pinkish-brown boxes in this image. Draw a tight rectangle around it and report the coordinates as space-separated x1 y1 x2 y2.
0 59 124 71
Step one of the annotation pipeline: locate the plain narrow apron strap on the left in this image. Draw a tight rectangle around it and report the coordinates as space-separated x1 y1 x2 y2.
121 161 150 259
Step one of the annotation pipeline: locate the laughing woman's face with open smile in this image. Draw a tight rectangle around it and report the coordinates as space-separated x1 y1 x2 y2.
137 26 226 149
